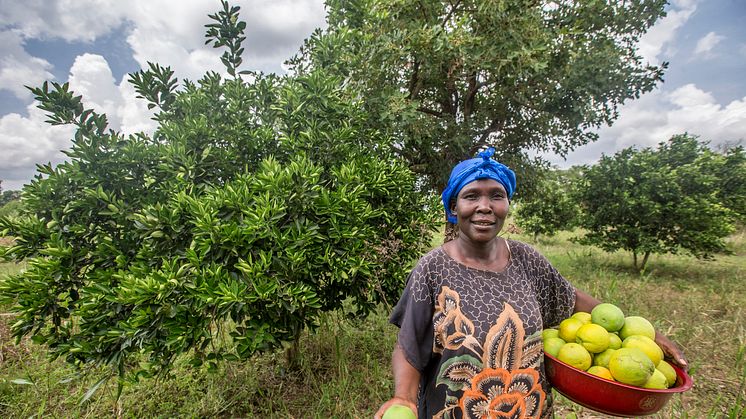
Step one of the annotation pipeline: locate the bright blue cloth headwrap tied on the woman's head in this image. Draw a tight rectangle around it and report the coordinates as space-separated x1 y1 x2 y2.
441 147 515 224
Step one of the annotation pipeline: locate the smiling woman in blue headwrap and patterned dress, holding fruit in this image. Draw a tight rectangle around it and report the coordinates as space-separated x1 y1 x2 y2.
376 148 686 418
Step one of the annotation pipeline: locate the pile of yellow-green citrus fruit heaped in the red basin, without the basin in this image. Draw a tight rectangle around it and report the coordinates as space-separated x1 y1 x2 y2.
542 303 676 389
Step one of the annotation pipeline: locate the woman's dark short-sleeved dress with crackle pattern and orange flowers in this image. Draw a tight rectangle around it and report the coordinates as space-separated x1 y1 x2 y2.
390 240 575 418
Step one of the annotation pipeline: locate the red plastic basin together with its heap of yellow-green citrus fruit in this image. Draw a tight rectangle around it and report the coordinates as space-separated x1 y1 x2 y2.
542 303 692 416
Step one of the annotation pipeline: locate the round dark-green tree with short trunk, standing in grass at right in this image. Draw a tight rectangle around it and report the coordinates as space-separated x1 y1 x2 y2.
579 134 733 270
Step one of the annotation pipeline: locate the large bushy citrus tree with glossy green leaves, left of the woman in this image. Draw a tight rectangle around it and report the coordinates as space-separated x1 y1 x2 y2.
0 2 436 390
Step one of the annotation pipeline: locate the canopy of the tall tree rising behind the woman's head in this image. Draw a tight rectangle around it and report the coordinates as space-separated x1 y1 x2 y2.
289 0 666 193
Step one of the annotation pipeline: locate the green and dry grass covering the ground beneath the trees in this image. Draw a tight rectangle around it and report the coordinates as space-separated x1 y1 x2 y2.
0 232 746 418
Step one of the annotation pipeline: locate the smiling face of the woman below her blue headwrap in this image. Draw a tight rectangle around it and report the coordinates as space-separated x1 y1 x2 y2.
454 179 510 243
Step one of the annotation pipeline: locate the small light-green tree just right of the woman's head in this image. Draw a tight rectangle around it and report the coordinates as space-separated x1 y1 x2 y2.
515 170 580 240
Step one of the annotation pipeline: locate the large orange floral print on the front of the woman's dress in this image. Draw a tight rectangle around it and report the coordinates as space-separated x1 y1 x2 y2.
433 294 546 419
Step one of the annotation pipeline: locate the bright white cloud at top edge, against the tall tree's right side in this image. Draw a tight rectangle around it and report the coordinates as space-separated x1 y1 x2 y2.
639 0 697 64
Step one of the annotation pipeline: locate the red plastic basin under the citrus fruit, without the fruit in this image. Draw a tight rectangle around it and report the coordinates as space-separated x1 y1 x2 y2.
544 352 693 416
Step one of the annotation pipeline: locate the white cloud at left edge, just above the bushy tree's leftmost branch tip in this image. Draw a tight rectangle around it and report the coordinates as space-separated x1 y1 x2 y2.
0 31 54 100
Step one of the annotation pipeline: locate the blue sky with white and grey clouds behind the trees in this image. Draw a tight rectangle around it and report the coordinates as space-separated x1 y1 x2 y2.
0 0 746 190
